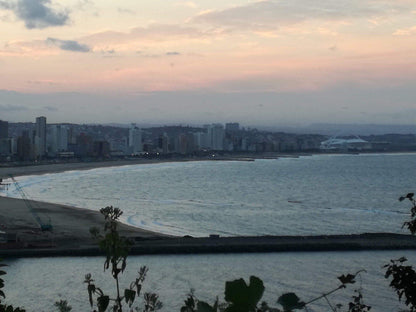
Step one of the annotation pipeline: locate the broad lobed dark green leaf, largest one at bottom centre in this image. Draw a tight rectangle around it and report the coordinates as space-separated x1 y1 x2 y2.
225 276 264 311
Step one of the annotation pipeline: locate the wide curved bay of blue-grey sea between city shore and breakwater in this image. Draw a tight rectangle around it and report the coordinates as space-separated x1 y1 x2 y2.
1 154 416 236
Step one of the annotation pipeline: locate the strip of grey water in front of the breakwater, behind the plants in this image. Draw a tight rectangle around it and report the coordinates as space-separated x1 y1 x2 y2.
4 251 416 312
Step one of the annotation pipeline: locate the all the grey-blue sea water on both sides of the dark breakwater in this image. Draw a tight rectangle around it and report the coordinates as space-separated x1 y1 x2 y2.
0 154 416 311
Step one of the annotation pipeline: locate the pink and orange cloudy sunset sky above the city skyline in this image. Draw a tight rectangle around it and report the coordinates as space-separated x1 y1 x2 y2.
0 0 416 126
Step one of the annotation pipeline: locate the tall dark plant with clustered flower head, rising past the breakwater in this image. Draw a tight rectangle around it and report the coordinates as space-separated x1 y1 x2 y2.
84 206 162 312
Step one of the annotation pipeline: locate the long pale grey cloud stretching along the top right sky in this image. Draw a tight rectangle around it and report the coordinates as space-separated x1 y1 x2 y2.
191 0 416 30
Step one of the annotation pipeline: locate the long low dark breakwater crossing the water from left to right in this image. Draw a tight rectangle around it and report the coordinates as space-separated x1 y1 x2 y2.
0 233 416 258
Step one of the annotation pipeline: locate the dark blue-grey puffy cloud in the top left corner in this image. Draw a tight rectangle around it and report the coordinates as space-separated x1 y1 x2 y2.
0 0 69 29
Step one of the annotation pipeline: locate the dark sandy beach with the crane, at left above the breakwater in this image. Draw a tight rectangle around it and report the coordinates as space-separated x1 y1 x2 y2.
0 197 169 248
